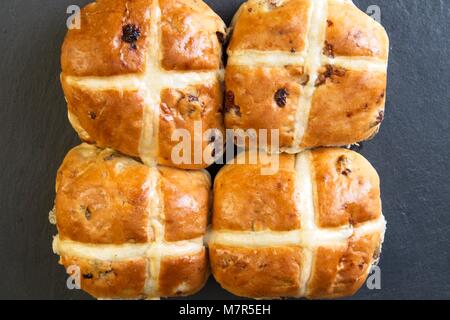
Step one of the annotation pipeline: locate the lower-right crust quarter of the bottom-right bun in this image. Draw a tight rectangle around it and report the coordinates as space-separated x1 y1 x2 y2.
307 232 381 299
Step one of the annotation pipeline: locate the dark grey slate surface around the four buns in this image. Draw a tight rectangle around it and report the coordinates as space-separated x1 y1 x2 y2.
0 0 450 299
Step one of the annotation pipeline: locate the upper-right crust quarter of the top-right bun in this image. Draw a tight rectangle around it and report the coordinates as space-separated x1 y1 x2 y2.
326 1 389 59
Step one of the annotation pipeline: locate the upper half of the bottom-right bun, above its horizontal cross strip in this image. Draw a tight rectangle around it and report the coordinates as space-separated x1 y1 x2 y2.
213 148 381 232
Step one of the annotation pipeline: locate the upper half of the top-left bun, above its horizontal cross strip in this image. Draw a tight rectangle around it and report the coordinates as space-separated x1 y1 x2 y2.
61 0 225 76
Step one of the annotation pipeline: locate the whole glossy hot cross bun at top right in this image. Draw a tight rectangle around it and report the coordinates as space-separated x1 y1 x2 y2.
225 0 389 153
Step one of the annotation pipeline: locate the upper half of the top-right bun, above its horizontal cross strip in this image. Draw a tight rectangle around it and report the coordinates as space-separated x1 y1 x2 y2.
228 0 389 59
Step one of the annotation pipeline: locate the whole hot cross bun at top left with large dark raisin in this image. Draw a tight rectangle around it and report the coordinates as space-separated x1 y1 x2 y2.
61 0 225 169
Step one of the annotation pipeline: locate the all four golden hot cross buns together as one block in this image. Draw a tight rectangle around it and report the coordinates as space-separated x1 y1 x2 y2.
53 0 389 299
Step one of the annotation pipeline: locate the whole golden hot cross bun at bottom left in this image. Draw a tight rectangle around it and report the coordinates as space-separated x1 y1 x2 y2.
53 144 211 299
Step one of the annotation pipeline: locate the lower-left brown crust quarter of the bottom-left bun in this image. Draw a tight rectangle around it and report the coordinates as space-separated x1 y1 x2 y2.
60 256 147 299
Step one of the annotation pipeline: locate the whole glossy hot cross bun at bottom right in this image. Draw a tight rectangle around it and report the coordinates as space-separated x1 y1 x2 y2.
208 148 385 299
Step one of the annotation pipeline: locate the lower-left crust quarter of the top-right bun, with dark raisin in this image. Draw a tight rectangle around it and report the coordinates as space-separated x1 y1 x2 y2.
225 65 303 147
